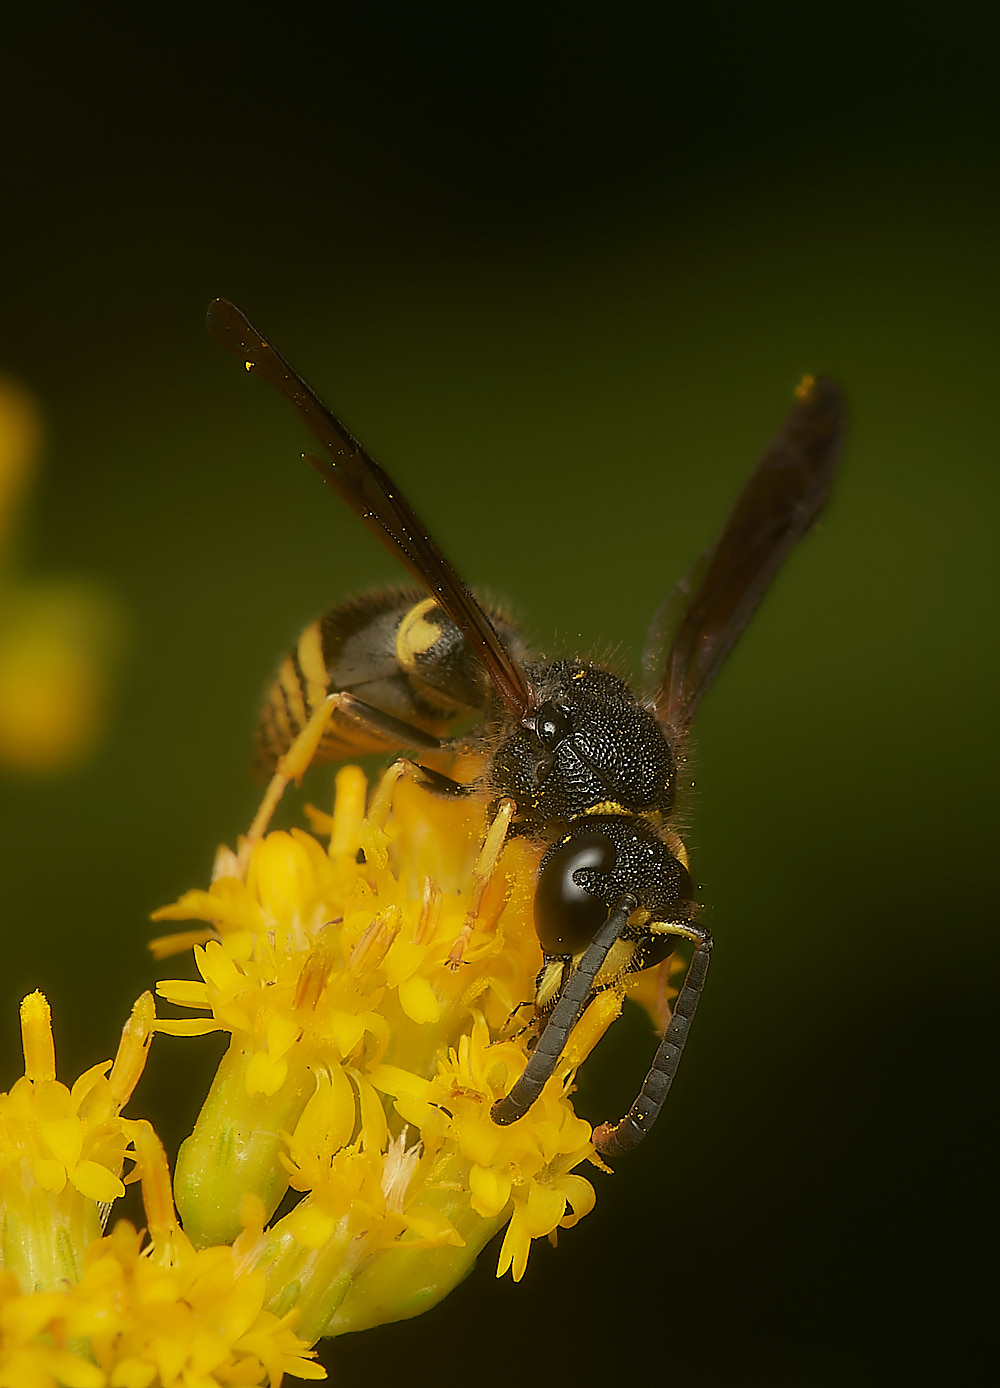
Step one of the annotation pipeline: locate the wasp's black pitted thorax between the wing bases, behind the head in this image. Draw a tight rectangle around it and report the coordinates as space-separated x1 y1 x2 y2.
490 661 676 836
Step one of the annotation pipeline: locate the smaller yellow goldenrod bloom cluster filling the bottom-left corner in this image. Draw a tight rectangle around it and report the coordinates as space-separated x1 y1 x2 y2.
0 992 324 1388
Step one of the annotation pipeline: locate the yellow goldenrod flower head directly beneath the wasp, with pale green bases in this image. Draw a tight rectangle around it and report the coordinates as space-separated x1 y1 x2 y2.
157 766 605 1338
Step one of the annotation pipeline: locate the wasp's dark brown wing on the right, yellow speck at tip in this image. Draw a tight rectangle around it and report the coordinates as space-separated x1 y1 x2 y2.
654 376 846 731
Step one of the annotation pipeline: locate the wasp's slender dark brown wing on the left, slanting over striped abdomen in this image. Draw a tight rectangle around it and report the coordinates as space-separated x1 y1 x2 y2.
207 298 531 716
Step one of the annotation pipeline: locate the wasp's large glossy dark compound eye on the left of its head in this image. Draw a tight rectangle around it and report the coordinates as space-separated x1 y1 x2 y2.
535 831 618 955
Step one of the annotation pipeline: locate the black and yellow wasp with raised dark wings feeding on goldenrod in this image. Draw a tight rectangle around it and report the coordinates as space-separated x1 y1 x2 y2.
208 298 846 1158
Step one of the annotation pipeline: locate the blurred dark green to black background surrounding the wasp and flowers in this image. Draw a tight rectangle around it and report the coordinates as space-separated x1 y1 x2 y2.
0 3 1000 1388
